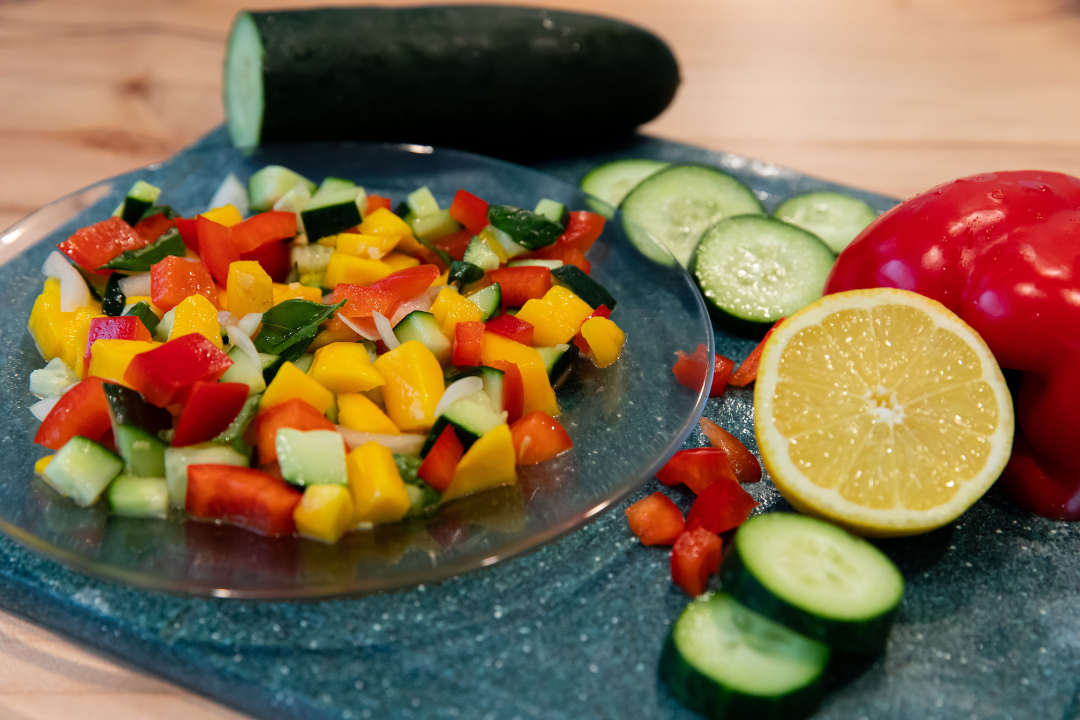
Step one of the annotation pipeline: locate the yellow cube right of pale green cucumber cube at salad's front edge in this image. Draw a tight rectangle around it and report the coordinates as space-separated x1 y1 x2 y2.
346 443 410 524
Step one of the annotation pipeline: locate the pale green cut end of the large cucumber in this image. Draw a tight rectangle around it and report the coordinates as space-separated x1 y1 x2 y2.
225 12 266 148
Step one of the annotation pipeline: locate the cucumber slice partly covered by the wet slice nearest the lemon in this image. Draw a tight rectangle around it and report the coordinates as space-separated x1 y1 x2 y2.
620 165 765 268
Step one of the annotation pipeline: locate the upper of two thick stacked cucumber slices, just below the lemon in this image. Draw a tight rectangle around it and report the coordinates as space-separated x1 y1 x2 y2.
720 513 904 654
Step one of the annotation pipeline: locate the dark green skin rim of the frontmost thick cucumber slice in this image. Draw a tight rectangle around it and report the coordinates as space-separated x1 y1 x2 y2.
660 630 827 720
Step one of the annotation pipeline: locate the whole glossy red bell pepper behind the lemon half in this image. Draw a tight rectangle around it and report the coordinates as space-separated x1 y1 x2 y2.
825 171 1080 519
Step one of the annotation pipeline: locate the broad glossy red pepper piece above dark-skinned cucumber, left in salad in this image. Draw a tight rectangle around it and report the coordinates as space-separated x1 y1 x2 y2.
124 332 232 407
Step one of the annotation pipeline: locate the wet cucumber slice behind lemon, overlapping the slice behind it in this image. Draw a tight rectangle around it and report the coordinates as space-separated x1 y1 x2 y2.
690 216 835 334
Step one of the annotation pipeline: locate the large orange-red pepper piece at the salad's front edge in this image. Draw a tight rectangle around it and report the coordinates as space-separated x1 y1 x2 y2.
185 465 302 535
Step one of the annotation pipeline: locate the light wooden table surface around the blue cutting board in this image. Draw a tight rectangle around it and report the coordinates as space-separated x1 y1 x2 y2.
0 0 1080 720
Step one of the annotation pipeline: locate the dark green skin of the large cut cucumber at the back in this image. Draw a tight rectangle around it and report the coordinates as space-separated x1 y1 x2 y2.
238 5 679 153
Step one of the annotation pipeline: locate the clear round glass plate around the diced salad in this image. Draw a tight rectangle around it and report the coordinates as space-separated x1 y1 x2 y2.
0 144 713 598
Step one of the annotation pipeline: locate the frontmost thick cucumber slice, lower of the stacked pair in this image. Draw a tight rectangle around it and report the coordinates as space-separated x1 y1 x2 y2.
660 593 829 720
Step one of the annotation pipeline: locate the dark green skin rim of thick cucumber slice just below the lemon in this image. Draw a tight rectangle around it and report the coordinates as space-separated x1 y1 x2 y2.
720 546 900 655
